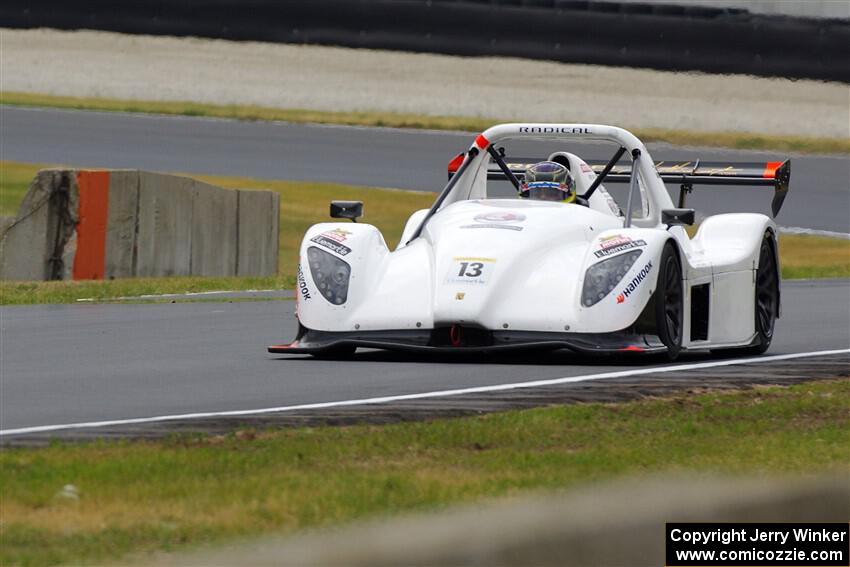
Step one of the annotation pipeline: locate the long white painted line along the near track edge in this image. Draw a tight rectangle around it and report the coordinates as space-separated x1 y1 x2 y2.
0 348 850 436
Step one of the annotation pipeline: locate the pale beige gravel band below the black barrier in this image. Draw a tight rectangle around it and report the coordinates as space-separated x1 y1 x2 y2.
0 29 850 139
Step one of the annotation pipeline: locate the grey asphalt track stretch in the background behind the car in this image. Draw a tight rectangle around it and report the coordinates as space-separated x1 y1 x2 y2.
0 106 850 233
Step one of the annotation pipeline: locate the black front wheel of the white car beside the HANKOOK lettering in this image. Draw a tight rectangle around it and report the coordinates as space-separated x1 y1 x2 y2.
654 242 685 360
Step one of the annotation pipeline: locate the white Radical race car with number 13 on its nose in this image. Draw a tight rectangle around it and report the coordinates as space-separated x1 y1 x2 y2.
268 124 790 360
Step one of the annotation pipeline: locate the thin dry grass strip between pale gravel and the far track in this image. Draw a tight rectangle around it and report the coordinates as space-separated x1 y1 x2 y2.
0 91 850 153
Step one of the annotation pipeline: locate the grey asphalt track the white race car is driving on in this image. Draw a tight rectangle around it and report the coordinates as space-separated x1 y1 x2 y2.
0 280 850 439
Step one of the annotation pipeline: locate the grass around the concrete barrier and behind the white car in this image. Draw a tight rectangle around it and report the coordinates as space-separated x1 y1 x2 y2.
0 161 850 305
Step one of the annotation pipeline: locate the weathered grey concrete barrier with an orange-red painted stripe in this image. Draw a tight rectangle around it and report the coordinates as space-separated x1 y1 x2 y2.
0 170 279 280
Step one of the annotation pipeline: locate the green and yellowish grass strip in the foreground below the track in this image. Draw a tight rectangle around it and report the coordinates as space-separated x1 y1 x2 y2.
0 380 850 565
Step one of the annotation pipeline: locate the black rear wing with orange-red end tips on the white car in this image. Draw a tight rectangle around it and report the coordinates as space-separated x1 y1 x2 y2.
449 156 791 217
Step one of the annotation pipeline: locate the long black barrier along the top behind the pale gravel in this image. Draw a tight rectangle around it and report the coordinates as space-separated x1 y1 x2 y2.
0 0 850 82
